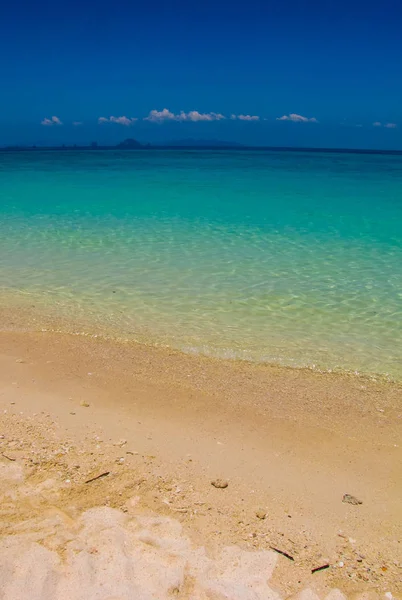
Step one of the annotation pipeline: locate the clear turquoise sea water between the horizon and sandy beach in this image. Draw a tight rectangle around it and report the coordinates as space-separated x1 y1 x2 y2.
0 150 402 379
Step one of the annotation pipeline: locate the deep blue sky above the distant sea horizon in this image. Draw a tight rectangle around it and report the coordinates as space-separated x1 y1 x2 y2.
0 0 402 149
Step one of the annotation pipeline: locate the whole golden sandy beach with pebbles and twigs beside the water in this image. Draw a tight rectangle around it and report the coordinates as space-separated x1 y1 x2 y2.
0 312 402 600
